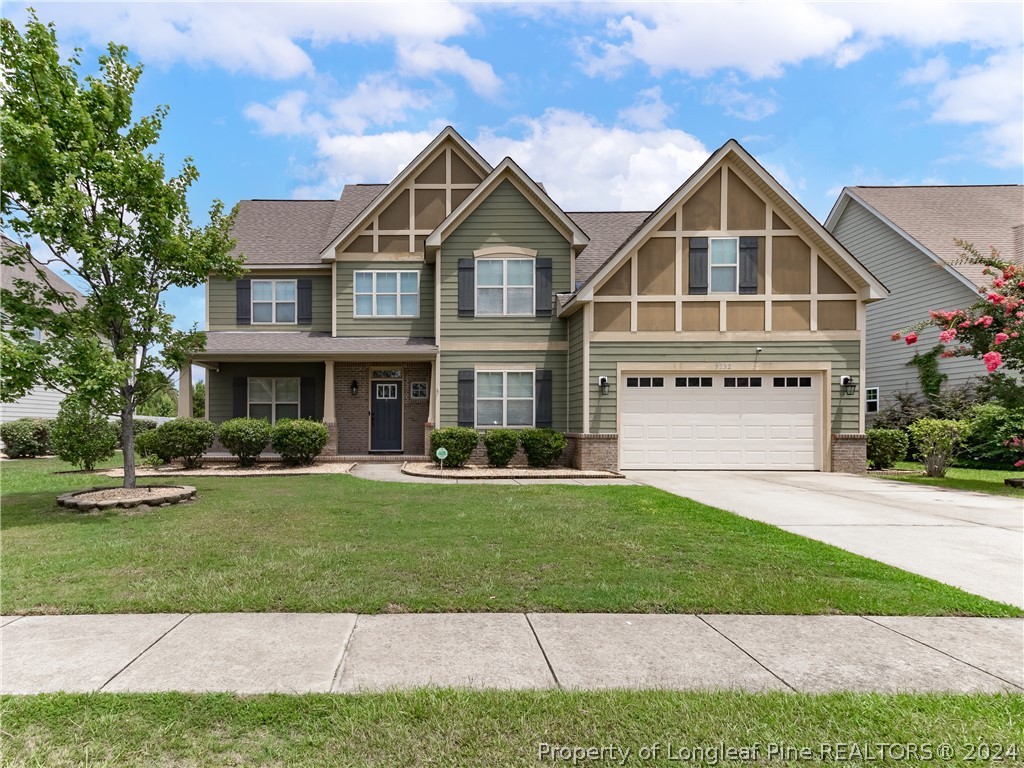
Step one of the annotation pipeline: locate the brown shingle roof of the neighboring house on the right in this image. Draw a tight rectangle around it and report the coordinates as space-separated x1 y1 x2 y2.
849 184 1024 287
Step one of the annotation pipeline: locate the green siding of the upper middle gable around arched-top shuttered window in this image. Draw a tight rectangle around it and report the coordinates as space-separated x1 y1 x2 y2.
438 181 572 341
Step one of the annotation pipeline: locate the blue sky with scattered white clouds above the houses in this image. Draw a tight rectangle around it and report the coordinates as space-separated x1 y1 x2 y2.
3 2 1024 346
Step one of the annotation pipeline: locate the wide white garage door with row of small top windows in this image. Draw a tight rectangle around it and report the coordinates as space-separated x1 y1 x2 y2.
618 372 821 469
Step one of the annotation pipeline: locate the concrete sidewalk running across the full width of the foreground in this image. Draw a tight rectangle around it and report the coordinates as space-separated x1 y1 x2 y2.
0 613 1024 694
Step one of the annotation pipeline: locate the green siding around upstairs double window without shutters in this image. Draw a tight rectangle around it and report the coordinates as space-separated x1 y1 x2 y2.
337 261 434 338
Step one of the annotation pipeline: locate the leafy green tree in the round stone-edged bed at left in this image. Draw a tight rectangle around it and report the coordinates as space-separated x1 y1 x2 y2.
0 11 242 487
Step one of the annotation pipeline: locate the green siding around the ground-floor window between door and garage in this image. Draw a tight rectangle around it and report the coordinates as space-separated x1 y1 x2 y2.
437 350 566 432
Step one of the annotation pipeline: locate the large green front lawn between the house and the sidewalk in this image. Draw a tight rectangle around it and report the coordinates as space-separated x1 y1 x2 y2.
0 461 1022 616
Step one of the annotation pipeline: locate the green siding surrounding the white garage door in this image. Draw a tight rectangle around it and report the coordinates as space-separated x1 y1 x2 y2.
590 341 863 434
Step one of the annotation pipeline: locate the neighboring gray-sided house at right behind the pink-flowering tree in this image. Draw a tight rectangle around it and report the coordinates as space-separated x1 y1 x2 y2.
825 184 1024 414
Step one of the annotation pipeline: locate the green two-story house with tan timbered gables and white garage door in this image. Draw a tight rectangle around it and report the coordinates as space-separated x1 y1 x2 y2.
186 128 886 470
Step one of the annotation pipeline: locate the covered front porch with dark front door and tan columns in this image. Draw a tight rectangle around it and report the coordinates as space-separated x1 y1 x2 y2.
186 332 437 461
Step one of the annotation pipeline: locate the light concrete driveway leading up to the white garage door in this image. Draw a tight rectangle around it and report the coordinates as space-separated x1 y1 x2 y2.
624 471 1024 607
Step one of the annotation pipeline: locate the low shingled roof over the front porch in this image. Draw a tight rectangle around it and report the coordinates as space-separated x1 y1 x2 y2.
195 331 437 360
